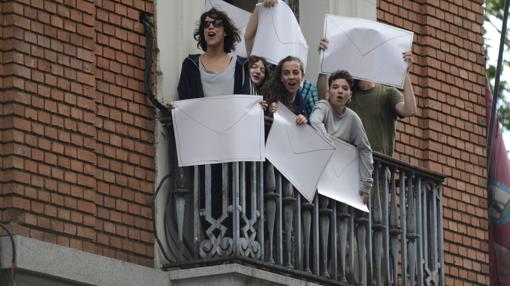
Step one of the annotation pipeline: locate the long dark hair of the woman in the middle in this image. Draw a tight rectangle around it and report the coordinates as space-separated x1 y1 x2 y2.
262 56 305 110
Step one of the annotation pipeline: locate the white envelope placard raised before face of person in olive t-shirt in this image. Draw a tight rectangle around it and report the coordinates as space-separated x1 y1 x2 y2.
321 15 413 88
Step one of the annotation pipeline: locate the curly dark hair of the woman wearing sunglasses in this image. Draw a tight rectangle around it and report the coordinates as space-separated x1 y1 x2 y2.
193 8 241 53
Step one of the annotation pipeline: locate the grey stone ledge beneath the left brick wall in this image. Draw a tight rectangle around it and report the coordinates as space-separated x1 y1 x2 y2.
0 236 171 286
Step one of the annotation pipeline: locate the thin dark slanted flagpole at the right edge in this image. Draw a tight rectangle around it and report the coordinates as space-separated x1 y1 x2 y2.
487 0 510 175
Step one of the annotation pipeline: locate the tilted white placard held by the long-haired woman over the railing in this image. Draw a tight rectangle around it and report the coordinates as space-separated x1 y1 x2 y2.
266 103 335 202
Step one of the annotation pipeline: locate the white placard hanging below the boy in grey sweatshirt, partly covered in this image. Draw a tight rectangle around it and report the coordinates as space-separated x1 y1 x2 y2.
317 138 368 212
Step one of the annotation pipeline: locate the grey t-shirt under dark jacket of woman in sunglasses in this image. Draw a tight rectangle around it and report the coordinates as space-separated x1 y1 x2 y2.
198 57 236 97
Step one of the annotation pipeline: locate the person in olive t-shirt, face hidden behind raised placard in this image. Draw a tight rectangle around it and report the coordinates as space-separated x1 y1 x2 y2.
317 38 416 156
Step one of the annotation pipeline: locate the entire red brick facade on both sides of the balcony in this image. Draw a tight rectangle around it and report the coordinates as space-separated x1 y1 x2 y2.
0 0 489 285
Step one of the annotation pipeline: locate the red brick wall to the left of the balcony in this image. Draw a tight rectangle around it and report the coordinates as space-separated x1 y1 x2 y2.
0 0 155 265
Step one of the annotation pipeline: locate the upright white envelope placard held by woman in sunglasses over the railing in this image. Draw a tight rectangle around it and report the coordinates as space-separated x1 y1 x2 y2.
172 95 265 166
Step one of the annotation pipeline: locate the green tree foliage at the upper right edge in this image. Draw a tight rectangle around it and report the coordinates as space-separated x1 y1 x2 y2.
485 0 510 130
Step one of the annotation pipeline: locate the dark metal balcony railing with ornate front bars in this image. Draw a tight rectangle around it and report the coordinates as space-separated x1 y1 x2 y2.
154 117 445 285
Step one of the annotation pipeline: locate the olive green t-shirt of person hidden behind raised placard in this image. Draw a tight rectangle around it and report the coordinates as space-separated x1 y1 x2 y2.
348 84 404 156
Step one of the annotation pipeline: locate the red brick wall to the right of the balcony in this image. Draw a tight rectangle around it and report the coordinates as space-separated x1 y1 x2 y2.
377 0 489 285
